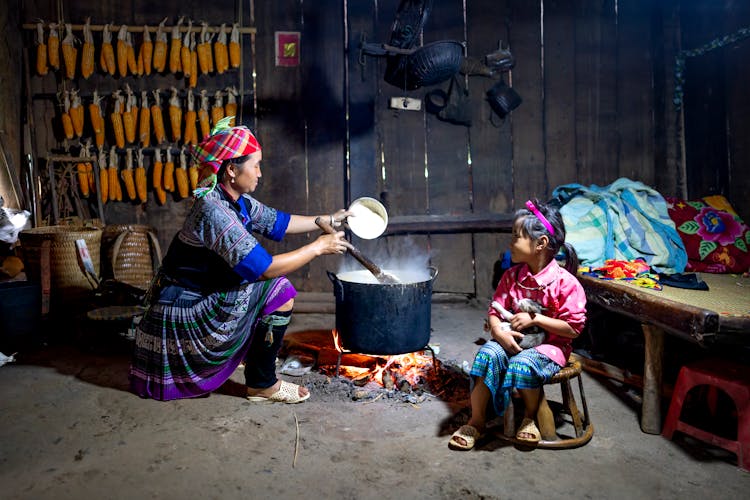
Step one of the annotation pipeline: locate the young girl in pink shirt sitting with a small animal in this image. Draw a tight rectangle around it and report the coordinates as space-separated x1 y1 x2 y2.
449 200 586 450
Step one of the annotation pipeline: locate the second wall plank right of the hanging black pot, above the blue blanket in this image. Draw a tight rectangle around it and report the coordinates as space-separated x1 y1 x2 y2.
544 0 578 195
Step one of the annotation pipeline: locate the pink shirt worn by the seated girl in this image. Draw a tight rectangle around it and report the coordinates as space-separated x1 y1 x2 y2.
488 259 586 366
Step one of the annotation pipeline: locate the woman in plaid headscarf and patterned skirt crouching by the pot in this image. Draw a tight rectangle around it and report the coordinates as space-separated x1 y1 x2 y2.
130 117 350 403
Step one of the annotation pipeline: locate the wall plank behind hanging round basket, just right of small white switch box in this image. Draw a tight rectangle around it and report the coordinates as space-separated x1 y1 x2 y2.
423 0 475 294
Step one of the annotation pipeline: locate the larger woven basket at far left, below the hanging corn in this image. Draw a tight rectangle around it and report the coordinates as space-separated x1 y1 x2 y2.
18 226 102 308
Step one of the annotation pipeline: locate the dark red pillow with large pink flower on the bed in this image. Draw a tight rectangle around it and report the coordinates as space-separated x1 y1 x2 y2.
665 195 750 273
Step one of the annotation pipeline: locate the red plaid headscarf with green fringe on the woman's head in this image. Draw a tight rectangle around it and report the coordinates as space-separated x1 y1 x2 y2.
190 116 260 198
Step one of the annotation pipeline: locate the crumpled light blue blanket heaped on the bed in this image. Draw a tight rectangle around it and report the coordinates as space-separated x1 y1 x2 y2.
552 178 687 274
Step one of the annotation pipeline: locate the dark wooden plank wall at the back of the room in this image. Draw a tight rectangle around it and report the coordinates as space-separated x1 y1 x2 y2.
7 0 750 297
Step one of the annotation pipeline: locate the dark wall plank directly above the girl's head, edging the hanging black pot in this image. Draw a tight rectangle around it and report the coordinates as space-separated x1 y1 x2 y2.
510 1 548 203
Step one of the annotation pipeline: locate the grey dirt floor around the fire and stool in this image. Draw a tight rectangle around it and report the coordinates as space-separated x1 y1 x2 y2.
0 294 750 499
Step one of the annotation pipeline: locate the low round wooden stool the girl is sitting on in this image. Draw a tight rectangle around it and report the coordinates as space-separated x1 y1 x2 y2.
501 361 594 449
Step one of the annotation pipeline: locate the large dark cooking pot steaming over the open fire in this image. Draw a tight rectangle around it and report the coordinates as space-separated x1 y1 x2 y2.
328 267 437 354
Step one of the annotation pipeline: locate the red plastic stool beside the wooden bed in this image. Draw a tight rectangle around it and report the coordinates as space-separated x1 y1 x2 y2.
662 359 750 471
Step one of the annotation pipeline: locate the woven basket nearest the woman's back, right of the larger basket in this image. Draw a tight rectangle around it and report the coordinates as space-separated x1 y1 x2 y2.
102 224 161 290
